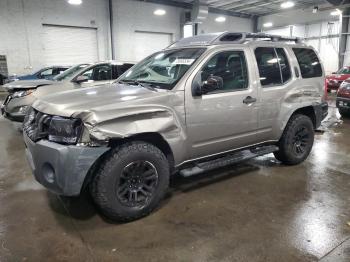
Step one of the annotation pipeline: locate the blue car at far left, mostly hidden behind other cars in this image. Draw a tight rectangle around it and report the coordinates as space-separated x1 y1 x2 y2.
7 66 70 83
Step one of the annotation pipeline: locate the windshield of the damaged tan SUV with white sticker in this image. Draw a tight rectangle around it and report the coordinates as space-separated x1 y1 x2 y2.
118 48 205 90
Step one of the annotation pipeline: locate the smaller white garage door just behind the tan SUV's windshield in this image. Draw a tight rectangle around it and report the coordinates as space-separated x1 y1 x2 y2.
133 31 172 61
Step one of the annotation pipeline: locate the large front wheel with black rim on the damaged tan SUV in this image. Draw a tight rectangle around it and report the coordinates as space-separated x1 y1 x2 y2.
91 141 170 222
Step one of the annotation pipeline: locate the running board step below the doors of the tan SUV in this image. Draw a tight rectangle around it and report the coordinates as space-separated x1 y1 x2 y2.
179 145 278 177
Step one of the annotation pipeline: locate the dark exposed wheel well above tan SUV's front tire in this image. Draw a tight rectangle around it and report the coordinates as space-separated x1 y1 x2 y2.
109 133 175 171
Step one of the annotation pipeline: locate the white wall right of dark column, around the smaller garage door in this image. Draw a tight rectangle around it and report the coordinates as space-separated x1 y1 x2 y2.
113 0 253 61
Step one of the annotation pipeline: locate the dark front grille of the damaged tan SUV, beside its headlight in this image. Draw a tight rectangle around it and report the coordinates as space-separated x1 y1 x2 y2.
23 108 52 142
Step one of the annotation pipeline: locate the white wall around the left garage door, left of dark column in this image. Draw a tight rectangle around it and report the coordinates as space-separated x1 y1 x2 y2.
0 0 110 74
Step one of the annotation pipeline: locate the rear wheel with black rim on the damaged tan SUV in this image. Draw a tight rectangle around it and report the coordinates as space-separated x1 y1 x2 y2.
274 114 315 165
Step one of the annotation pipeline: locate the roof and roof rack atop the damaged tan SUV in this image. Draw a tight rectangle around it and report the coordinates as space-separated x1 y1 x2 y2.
169 32 302 48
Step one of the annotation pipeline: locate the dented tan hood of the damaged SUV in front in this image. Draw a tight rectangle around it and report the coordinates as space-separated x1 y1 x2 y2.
33 84 171 124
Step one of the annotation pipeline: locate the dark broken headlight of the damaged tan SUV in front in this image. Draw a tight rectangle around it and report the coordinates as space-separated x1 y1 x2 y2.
49 116 83 145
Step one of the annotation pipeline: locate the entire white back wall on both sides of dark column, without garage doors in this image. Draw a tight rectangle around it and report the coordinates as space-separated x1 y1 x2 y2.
0 0 253 74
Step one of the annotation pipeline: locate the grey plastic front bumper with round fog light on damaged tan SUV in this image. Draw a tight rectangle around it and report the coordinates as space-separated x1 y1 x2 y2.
23 132 109 196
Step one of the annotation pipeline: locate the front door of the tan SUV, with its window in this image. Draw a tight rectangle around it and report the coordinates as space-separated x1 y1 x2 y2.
185 50 258 158
